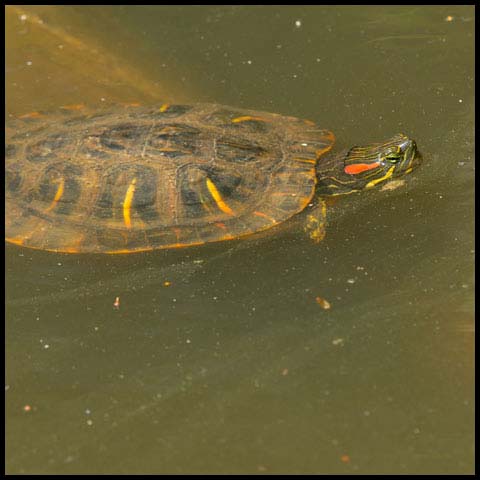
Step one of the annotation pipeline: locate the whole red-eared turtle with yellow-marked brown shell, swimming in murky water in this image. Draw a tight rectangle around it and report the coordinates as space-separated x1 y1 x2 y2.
5 103 421 254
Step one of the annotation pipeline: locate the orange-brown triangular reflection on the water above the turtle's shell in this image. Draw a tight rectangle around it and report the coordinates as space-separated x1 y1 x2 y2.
5 6 193 114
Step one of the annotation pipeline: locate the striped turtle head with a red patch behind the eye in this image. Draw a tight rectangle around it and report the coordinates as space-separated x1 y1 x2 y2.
318 133 421 195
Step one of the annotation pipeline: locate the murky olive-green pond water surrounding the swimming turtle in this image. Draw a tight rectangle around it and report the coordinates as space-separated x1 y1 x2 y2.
6 6 474 474
